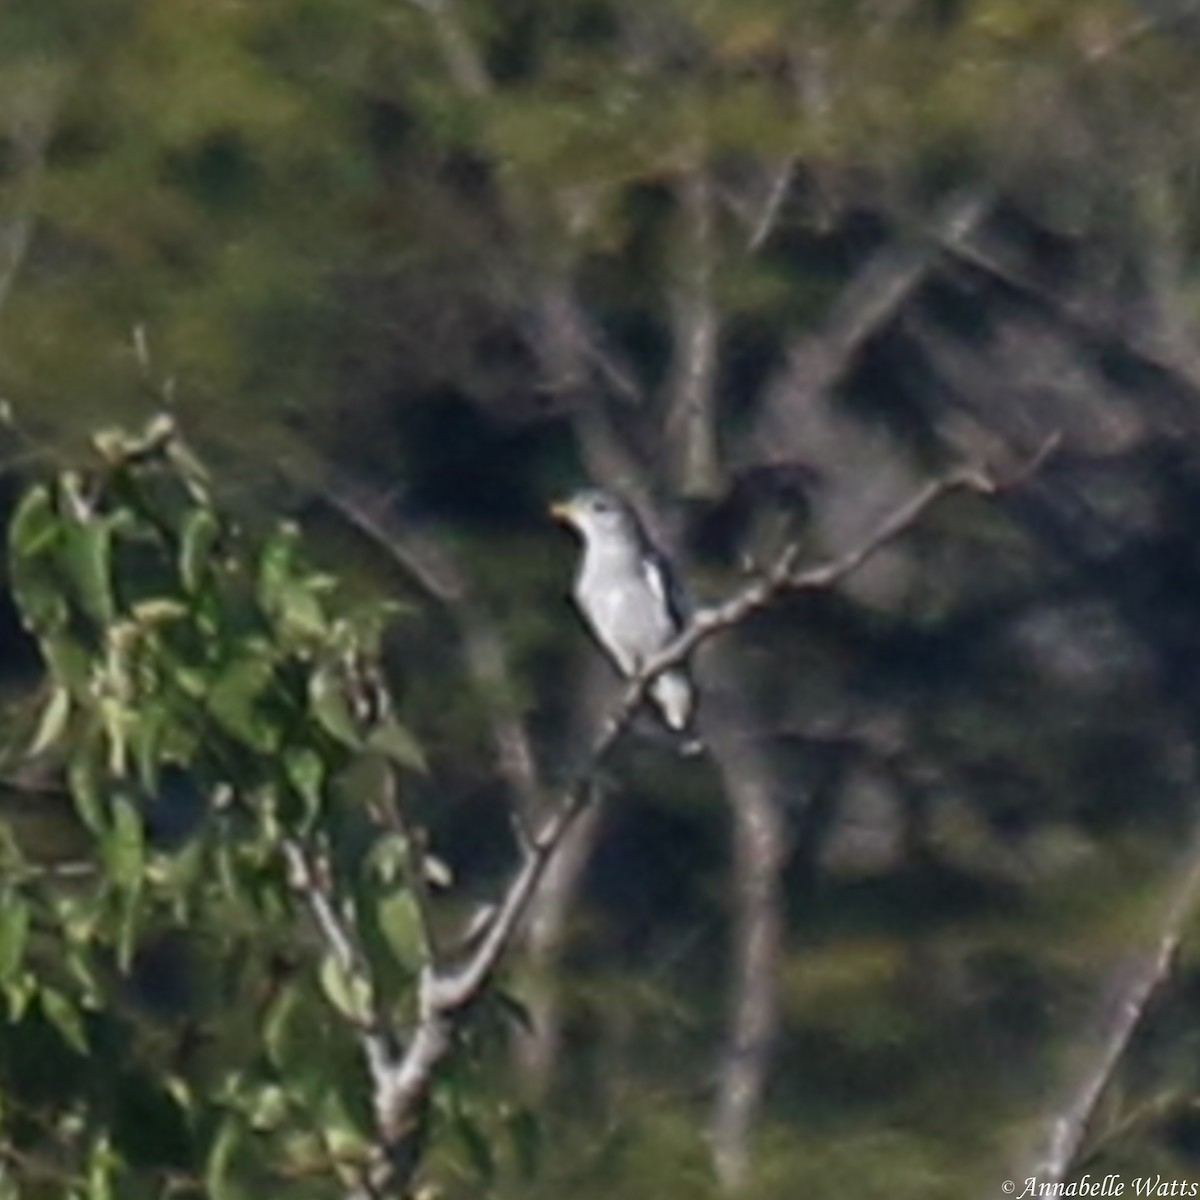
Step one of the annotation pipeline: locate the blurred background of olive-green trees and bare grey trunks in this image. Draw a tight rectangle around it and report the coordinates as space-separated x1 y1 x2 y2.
0 0 1200 1198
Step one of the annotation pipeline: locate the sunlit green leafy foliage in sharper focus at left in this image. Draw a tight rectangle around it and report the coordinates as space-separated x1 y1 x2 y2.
0 420 424 1200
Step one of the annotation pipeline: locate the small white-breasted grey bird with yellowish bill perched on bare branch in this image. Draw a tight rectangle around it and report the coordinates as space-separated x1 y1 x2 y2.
551 488 700 751
